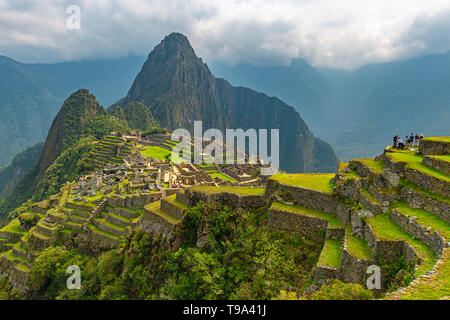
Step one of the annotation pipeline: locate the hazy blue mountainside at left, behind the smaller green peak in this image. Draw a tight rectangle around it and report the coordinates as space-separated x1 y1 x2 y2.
0 56 145 167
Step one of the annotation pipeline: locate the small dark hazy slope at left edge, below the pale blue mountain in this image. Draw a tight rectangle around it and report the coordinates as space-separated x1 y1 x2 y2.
0 142 44 198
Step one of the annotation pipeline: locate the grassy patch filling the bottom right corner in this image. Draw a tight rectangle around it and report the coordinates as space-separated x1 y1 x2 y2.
387 249 450 300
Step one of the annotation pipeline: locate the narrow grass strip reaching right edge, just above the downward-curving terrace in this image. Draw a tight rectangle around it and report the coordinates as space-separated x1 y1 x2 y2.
392 202 450 240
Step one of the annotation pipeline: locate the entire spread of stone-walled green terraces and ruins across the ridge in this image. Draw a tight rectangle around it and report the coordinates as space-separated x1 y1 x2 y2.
0 135 450 299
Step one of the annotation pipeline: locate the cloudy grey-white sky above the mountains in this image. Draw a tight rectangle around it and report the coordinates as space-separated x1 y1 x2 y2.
0 0 450 69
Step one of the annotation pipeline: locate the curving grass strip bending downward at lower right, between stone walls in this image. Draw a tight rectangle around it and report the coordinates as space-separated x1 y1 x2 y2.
366 213 437 276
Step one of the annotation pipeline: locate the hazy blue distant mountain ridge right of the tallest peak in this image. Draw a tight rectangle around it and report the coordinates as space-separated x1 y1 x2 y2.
212 53 450 160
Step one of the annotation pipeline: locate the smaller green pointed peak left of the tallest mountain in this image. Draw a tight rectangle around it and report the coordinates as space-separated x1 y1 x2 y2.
0 89 128 216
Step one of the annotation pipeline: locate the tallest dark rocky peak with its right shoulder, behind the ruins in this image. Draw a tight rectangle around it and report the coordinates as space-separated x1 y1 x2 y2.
118 33 337 172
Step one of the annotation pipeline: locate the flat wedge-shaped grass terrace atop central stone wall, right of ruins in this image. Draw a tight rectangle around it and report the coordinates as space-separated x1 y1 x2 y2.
270 173 335 194
